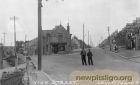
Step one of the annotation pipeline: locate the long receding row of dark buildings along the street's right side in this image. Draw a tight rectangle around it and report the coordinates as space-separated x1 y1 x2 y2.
100 17 140 50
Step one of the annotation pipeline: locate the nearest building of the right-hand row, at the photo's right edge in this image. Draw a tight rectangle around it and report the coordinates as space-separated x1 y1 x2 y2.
126 18 140 49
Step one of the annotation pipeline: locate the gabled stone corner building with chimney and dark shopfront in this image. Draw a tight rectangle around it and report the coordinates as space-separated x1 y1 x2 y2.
42 23 71 54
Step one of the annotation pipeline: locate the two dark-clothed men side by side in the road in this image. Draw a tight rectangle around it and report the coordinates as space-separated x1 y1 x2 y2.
81 49 93 65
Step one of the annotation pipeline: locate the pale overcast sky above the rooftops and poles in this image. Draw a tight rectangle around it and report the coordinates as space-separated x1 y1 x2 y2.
0 0 140 46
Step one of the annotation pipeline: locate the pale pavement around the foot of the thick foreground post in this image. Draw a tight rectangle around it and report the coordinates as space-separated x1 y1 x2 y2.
23 61 57 85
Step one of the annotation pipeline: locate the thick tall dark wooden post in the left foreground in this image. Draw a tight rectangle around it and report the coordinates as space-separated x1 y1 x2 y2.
38 0 42 70
